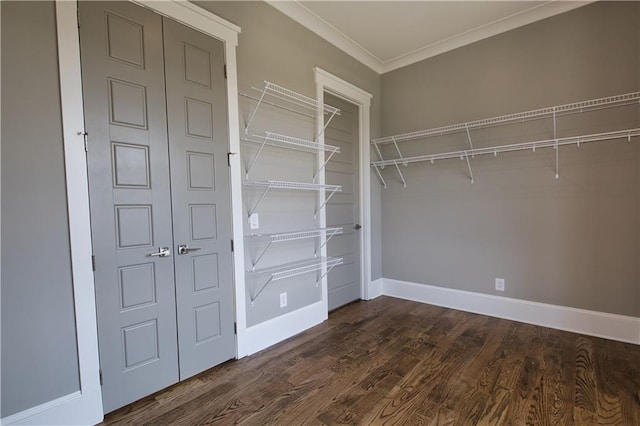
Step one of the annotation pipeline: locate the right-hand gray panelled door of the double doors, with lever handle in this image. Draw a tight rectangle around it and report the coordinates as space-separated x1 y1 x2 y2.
164 19 235 379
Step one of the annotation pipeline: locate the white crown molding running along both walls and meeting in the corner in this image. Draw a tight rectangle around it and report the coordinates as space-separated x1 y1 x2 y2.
265 0 593 74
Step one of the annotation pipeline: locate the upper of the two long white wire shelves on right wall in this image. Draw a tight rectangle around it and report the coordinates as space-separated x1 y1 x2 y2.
371 92 640 146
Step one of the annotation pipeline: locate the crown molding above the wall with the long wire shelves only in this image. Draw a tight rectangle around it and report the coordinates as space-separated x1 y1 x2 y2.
381 0 593 74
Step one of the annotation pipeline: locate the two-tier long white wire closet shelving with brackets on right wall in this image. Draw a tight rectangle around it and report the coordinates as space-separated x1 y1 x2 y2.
371 92 640 188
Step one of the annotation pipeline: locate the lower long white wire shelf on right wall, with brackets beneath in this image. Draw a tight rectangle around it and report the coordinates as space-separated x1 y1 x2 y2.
371 128 640 188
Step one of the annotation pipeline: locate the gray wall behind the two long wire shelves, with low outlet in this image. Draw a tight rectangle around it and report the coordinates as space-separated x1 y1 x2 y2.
382 2 640 316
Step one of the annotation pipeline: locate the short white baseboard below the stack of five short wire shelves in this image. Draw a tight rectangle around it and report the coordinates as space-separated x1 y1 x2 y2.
238 302 328 356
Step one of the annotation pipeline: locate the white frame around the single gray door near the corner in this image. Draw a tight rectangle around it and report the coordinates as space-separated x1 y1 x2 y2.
314 67 373 310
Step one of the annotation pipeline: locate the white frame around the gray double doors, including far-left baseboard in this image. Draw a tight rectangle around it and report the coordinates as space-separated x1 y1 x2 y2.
0 0 240 425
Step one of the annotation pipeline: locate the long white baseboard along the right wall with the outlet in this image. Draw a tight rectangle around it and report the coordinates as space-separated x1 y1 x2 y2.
382 278 640 345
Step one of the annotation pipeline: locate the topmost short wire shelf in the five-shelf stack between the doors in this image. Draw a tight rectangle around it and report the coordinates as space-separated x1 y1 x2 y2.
244 81 340 134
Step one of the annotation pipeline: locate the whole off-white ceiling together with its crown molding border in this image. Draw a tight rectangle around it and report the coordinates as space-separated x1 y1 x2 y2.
266 0 589 74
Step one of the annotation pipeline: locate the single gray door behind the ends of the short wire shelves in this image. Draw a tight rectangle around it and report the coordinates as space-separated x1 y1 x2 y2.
325 93 361 310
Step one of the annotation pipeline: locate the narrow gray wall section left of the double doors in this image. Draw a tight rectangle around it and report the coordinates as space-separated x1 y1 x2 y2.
0 1 79 417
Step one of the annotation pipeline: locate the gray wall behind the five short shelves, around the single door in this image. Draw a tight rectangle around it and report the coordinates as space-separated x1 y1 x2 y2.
195 2 381 325
